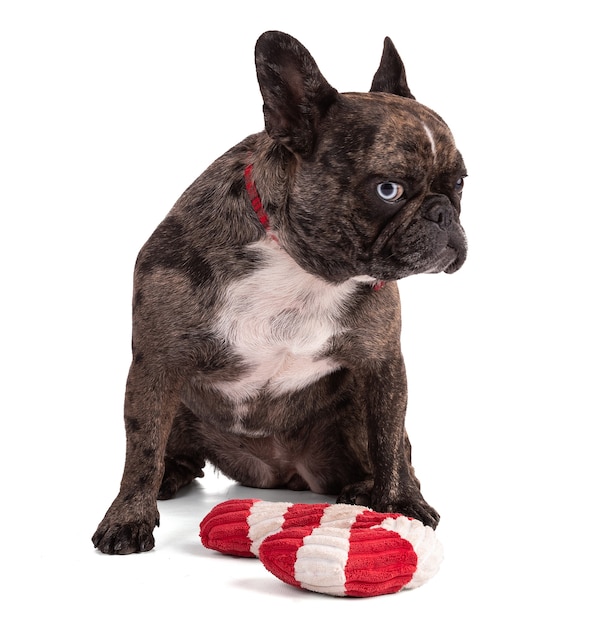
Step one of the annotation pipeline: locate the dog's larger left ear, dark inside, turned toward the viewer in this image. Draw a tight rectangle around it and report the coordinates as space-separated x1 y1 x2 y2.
256 31 338 157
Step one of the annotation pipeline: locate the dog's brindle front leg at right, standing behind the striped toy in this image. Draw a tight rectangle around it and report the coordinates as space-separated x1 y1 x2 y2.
367 355 440 528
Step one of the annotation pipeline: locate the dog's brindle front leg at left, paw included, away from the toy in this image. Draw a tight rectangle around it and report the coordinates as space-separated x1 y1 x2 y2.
92 363 180 554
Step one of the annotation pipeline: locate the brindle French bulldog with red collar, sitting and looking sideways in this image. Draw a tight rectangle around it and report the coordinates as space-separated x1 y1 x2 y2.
92 31 467 554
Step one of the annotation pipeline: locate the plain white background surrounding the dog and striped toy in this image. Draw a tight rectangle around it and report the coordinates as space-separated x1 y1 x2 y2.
0 0 604 624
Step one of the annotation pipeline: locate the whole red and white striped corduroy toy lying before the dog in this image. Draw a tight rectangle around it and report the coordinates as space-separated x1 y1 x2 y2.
200 499 442 597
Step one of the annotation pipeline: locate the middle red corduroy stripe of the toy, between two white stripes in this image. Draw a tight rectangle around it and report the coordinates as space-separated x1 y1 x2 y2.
260 503 329 587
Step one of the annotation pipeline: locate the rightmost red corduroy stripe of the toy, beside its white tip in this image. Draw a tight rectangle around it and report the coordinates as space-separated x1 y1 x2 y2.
344 511 417 597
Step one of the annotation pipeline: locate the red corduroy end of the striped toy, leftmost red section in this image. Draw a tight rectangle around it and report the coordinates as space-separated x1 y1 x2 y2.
199 498 259 557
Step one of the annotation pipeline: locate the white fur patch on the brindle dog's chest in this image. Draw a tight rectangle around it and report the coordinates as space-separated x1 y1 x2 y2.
214 239 358 404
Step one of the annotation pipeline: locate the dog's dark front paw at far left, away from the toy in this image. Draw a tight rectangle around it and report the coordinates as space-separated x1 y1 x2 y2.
92 500 159 554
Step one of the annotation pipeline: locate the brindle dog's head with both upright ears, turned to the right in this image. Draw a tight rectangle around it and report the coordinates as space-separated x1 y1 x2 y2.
256 32 466 281
